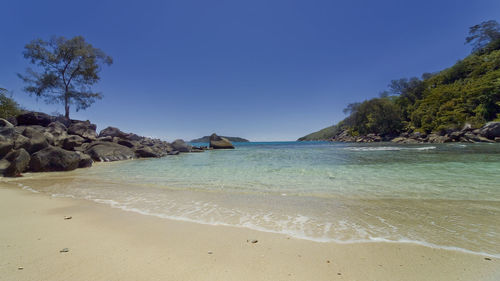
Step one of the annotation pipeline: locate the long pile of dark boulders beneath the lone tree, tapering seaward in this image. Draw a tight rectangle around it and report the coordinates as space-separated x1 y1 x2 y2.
0 112 202 177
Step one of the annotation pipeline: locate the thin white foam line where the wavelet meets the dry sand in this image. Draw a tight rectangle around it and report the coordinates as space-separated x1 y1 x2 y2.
84 195 500 259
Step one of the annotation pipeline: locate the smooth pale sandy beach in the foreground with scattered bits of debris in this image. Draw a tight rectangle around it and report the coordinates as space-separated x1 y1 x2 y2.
0 183 500 280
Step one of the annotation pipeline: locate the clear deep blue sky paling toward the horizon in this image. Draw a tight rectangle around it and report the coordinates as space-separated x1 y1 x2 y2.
0 0 500 140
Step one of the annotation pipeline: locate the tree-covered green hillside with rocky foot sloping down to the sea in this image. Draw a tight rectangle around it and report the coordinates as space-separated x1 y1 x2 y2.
298 22 500 143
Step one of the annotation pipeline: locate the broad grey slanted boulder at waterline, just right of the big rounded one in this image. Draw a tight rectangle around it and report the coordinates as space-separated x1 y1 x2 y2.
85 142 135 162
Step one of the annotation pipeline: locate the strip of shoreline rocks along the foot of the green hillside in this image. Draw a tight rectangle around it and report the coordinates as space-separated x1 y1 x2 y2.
331 122 500 144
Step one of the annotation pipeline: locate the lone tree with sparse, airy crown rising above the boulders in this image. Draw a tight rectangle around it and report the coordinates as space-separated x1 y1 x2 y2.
18 36 113 119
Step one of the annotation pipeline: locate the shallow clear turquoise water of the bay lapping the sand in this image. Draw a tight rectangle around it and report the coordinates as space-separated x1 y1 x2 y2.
6 142 500 257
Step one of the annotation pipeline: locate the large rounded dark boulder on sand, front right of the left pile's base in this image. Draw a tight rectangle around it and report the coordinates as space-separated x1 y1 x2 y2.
30 146 80 172
